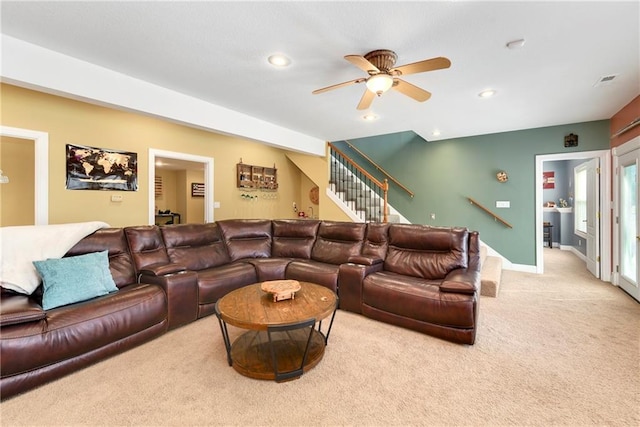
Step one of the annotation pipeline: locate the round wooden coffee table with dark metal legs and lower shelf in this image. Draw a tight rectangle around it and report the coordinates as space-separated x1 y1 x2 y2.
216 282 338 381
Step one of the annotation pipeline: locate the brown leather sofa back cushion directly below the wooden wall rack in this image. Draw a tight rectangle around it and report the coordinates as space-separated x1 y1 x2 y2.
218 219 271 261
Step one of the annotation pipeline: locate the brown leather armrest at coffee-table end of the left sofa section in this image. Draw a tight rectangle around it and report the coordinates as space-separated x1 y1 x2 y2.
139 271 198 329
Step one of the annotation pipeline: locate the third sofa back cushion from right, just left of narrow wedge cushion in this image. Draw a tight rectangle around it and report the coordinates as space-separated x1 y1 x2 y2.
311 221 367 264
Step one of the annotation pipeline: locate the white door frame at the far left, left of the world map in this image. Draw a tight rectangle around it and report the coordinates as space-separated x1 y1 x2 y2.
0 126 49 225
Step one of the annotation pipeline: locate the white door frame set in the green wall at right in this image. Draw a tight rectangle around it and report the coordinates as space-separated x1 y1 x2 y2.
535 150 612 282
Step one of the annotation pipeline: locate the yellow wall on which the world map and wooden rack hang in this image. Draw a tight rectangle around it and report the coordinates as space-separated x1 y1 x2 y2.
0 84 324 227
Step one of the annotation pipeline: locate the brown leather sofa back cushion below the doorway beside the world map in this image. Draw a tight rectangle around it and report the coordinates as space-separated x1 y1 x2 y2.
160 223 230 271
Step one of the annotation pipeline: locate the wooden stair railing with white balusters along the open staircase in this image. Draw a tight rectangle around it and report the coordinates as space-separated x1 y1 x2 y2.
329 143 389 222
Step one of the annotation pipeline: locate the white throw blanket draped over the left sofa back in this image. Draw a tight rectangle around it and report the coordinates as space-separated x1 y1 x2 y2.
0 221 109 295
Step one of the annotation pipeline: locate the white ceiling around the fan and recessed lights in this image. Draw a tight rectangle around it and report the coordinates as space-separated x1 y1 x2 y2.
1 0 640 145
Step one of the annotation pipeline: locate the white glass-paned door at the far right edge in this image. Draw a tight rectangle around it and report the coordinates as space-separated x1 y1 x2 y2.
613 136 640 301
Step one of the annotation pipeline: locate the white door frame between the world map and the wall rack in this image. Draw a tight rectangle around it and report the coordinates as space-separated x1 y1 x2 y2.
149 148 213 225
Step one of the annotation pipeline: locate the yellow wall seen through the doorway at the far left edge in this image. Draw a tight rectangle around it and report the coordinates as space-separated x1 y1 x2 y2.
0 136 35 226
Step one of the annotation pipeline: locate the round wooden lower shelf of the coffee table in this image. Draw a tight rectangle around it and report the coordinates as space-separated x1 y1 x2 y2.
231 328 326 381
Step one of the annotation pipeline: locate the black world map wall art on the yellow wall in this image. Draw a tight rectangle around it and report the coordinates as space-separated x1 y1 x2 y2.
66 144 138 191
